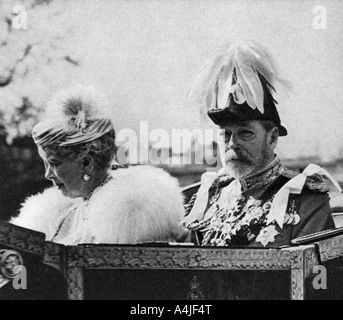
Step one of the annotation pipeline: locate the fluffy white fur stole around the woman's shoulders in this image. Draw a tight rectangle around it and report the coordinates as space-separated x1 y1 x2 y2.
10 166 184 245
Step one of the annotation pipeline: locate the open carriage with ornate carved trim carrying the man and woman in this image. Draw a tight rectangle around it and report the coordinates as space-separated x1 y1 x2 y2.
0 215 343 300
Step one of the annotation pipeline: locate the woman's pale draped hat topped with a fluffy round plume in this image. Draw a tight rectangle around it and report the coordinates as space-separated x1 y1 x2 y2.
32 85 114 147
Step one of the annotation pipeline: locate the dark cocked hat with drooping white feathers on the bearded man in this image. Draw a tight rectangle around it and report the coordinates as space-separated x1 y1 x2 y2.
189 43 290 136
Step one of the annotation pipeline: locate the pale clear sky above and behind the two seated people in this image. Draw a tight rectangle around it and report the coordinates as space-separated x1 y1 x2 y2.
2 0 343 159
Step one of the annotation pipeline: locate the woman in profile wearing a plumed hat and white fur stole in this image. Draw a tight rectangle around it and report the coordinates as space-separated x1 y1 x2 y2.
11 87 184 245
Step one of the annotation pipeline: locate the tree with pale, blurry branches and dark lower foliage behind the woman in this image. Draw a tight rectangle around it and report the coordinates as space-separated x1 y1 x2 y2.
0 0 80 220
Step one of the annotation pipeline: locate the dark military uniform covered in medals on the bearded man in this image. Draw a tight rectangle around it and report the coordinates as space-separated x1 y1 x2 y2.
183 158 335 247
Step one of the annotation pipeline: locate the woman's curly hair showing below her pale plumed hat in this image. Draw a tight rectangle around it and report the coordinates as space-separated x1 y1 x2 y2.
42 130 117 169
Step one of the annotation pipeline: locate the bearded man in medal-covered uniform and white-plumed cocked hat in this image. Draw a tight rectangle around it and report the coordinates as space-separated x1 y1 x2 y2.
182 44 341 299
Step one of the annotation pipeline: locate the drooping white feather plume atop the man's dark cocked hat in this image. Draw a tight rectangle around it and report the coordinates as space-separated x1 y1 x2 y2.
186 42 291 113
